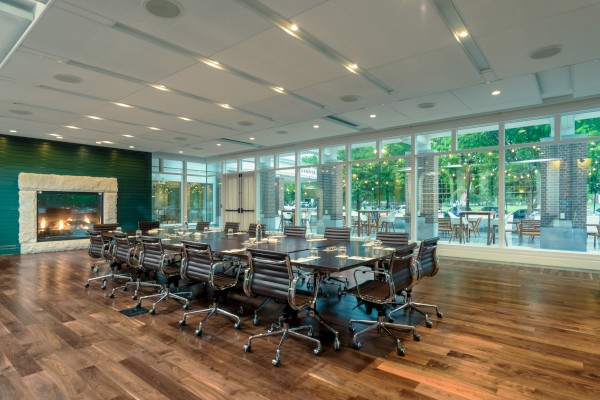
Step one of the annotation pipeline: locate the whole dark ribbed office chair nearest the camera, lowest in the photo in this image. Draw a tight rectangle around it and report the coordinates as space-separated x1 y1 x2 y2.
244 249 322 367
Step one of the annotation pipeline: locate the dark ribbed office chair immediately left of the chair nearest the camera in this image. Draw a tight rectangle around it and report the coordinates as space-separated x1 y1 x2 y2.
179 240 241 336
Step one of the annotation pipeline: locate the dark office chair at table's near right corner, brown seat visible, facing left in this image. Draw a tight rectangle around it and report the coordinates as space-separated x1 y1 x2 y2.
349 244 421 356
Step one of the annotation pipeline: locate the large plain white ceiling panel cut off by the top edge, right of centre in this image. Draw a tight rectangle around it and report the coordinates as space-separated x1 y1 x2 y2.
294 0 454 68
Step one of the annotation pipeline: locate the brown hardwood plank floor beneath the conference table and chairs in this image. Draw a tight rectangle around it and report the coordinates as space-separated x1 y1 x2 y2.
0 251 600 400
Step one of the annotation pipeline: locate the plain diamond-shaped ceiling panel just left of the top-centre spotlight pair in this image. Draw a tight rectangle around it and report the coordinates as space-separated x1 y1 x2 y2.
214 28 349 90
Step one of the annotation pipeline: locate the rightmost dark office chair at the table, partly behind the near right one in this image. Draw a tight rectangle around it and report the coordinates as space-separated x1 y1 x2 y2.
389 237 444 328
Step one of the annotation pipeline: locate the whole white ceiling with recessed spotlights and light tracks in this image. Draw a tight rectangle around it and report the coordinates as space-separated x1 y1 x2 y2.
0 0 600 157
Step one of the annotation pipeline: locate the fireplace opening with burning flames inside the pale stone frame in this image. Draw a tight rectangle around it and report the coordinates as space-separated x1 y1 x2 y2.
37 191 103 242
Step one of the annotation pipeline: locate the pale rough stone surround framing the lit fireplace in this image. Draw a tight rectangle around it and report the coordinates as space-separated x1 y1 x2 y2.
19 172 118 254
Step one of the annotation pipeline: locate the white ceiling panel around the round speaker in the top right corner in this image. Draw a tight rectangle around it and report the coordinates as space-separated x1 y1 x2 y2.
478 4 600 78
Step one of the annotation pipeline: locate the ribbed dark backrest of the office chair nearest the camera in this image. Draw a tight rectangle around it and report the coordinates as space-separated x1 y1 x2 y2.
244 249 293 301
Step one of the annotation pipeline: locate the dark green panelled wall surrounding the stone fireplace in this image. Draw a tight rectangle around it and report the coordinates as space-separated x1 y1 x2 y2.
0 135 152 254
